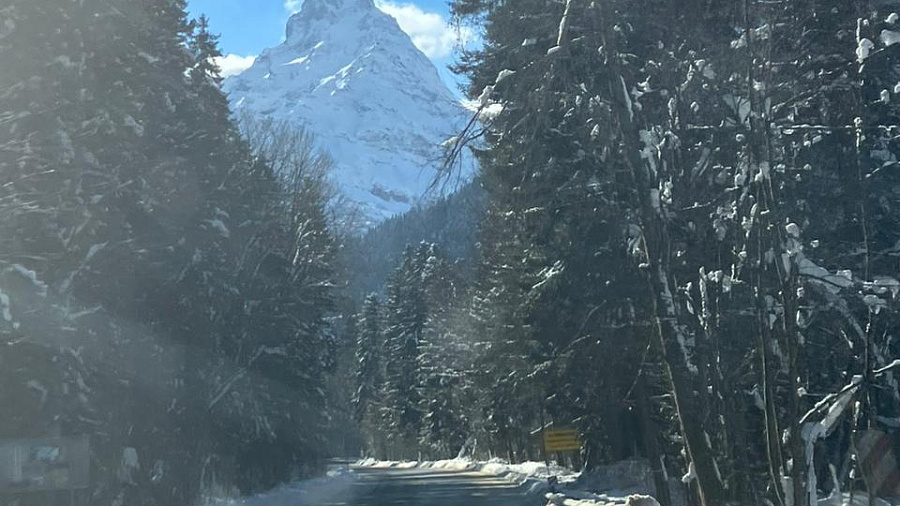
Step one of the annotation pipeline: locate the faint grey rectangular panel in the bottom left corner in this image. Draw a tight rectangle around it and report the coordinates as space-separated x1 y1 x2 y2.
0 436 90 492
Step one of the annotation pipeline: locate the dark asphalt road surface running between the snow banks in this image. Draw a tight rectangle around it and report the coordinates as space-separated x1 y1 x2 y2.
316 468 541 506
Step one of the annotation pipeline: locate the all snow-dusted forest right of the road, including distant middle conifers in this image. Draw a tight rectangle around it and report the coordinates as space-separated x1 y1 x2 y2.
355 0 900 506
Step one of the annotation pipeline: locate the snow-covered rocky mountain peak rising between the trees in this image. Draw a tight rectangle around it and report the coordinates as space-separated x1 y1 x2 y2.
224 0 471 225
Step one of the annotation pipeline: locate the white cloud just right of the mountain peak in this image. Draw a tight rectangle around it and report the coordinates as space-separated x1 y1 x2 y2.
375 0 472 59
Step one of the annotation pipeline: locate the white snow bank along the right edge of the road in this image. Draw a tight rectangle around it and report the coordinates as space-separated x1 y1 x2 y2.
356 459 659 506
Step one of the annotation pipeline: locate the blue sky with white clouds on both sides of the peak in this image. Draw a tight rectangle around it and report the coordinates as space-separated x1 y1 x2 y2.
188 0 474 91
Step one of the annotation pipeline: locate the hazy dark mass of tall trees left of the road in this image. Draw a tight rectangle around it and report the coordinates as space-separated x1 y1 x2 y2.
0 0 336 505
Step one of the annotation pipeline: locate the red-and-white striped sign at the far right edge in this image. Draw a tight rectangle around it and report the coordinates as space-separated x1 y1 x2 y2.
855 429 900 497
